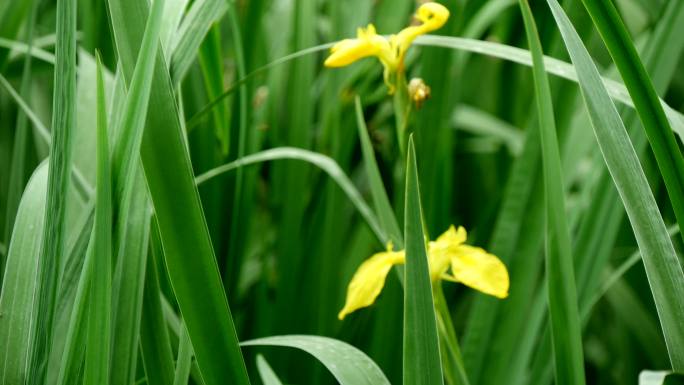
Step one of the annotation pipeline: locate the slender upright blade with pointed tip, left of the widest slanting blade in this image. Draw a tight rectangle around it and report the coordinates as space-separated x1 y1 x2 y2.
84 54 112 385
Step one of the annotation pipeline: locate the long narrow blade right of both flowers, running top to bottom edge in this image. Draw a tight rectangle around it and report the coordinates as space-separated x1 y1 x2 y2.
519 0 585 385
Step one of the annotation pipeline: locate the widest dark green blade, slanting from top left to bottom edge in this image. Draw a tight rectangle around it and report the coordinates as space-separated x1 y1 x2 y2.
108 0 249 385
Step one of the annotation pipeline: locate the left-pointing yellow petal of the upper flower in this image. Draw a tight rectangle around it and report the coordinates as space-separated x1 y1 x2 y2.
324 24 390 67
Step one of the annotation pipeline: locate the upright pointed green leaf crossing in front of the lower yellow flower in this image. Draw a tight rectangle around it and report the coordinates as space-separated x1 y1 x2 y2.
404 135 444 385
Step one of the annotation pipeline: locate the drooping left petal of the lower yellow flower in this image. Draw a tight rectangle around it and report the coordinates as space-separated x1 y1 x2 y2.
337 244 405 320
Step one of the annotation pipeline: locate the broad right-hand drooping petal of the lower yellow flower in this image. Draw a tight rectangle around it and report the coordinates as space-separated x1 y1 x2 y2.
451 245 509 298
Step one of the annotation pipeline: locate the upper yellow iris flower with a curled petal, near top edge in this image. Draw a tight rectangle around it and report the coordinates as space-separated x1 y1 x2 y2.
325 3 449 93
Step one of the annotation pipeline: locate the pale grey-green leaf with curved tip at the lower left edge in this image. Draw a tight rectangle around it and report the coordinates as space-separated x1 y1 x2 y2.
0 163 48 384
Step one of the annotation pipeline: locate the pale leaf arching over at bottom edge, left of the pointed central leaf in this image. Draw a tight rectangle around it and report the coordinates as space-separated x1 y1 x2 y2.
240 335 389 385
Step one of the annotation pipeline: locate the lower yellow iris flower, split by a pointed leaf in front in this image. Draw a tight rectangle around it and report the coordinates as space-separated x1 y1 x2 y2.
338 226 509 320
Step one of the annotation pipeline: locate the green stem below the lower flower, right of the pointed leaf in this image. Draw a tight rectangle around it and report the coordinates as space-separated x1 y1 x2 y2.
432 282 470 385
